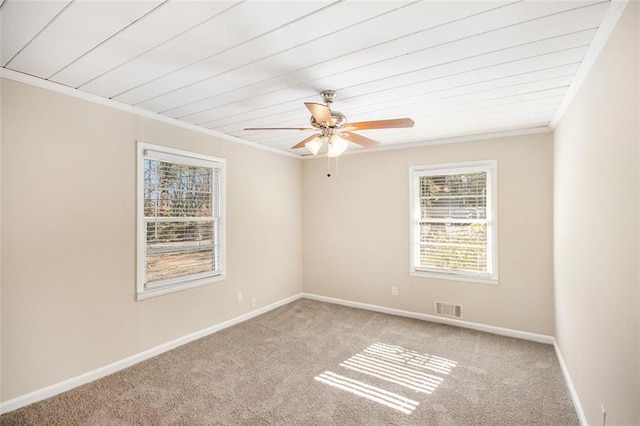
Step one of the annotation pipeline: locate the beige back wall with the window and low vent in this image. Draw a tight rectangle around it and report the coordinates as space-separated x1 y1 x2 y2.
303 133 554 335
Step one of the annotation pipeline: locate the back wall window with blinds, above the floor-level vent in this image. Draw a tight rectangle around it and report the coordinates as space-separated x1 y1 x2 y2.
410 161 498 284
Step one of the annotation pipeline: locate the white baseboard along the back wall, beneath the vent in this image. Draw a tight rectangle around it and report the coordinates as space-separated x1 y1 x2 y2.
302 293 554 345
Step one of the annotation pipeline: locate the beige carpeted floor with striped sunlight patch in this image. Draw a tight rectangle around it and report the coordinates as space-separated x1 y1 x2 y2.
0 299 579 426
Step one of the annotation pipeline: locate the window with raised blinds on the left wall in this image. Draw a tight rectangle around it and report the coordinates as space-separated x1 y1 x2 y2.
137 142 225 300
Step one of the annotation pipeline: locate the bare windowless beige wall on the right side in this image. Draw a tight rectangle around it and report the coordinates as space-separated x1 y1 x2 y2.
554 2 640 425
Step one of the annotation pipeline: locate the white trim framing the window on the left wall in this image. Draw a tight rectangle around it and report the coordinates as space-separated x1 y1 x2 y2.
136 141 227 300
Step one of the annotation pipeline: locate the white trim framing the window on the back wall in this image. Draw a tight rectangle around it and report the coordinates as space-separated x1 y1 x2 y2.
409 160 498 285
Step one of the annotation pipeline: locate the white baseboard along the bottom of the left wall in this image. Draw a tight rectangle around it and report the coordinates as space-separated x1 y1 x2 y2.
0 293 302 414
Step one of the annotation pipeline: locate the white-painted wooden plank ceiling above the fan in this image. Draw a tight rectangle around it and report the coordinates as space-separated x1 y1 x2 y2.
0 0 610 155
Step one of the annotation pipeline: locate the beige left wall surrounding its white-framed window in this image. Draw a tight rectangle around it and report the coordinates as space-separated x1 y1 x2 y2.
1 80 302 401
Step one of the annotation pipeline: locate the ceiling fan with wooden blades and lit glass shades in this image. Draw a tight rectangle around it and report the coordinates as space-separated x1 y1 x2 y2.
244 90 414 157
